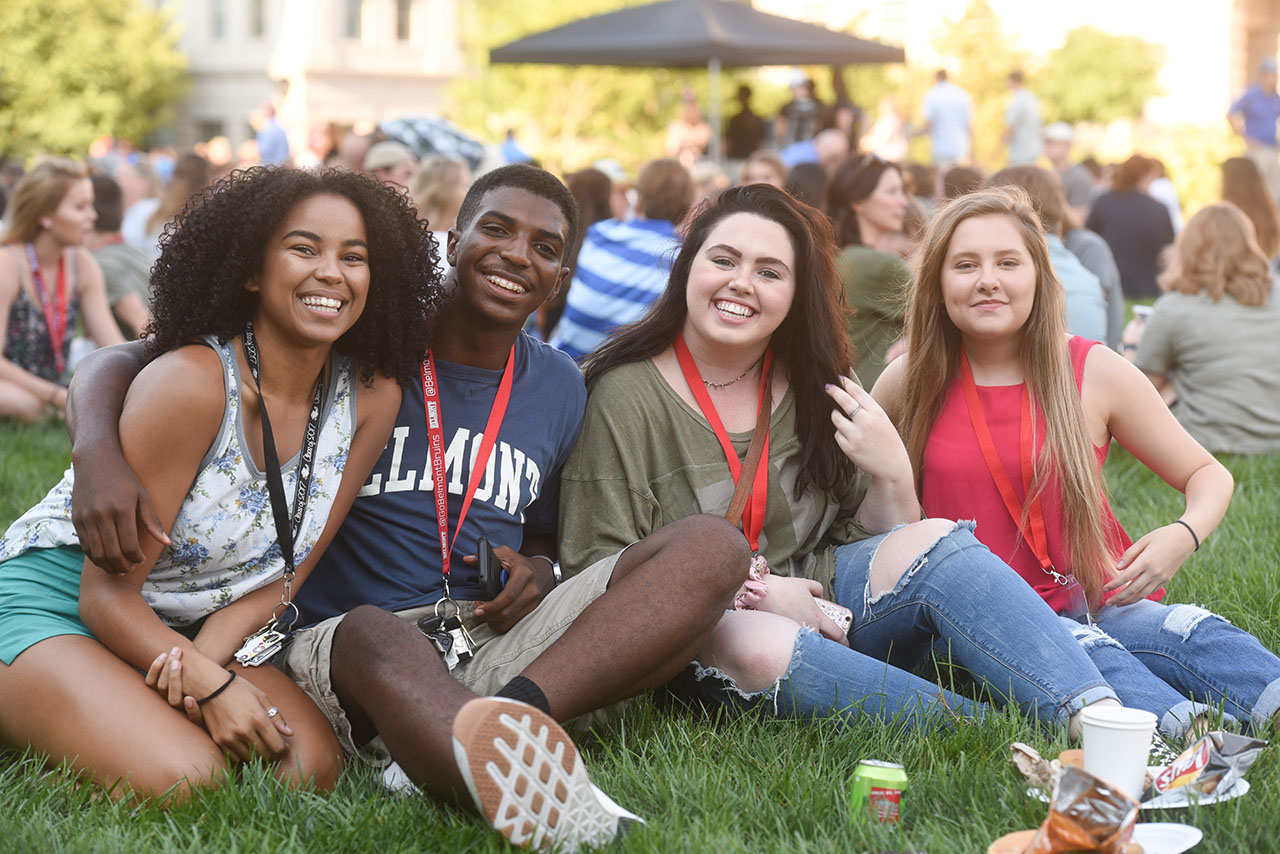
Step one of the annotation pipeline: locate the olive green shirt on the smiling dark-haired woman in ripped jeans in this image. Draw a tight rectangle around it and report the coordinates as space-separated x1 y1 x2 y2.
559 360 872 595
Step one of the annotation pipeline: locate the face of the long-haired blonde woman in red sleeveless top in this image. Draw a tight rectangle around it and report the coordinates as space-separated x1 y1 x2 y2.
942 214 1038 342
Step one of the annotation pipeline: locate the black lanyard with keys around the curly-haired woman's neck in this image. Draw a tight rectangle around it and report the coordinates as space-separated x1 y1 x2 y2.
236 323 324 666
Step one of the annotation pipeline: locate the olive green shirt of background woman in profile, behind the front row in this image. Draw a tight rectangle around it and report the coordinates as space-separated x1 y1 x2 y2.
836 246 911 388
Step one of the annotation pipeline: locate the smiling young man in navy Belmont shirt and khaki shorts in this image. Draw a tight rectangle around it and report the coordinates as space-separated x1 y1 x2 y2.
67 165 749 848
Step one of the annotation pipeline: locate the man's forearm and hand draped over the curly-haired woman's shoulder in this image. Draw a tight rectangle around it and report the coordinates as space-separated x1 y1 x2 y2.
67 341 169 574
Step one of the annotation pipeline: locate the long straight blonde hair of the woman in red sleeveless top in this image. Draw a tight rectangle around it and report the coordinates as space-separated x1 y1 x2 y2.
897 187 1119 604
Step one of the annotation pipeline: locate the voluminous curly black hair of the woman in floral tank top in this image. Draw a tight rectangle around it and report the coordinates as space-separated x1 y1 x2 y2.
145 166 442 384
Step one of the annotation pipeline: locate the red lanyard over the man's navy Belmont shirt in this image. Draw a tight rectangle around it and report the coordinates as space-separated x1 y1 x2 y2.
422 344 516 599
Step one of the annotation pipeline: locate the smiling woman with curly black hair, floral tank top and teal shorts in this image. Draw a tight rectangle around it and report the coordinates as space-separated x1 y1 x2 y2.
0 168 439 796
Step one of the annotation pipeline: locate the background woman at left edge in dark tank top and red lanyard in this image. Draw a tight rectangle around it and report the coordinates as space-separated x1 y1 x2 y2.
0 157 124 421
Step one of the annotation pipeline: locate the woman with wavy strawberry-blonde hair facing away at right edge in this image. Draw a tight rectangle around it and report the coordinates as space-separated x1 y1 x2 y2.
1134 202 1280 453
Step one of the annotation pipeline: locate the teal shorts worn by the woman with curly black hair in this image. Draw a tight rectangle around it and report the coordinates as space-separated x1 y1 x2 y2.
0 545 93 666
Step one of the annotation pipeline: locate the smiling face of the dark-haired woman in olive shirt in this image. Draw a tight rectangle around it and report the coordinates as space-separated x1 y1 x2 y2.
684 214 796 348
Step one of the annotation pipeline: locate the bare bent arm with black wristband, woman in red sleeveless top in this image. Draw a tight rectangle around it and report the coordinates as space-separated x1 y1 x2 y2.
1083 347 1234 604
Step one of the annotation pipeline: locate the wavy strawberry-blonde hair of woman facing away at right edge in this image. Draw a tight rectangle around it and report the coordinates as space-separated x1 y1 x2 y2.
1160 202 1271 306
